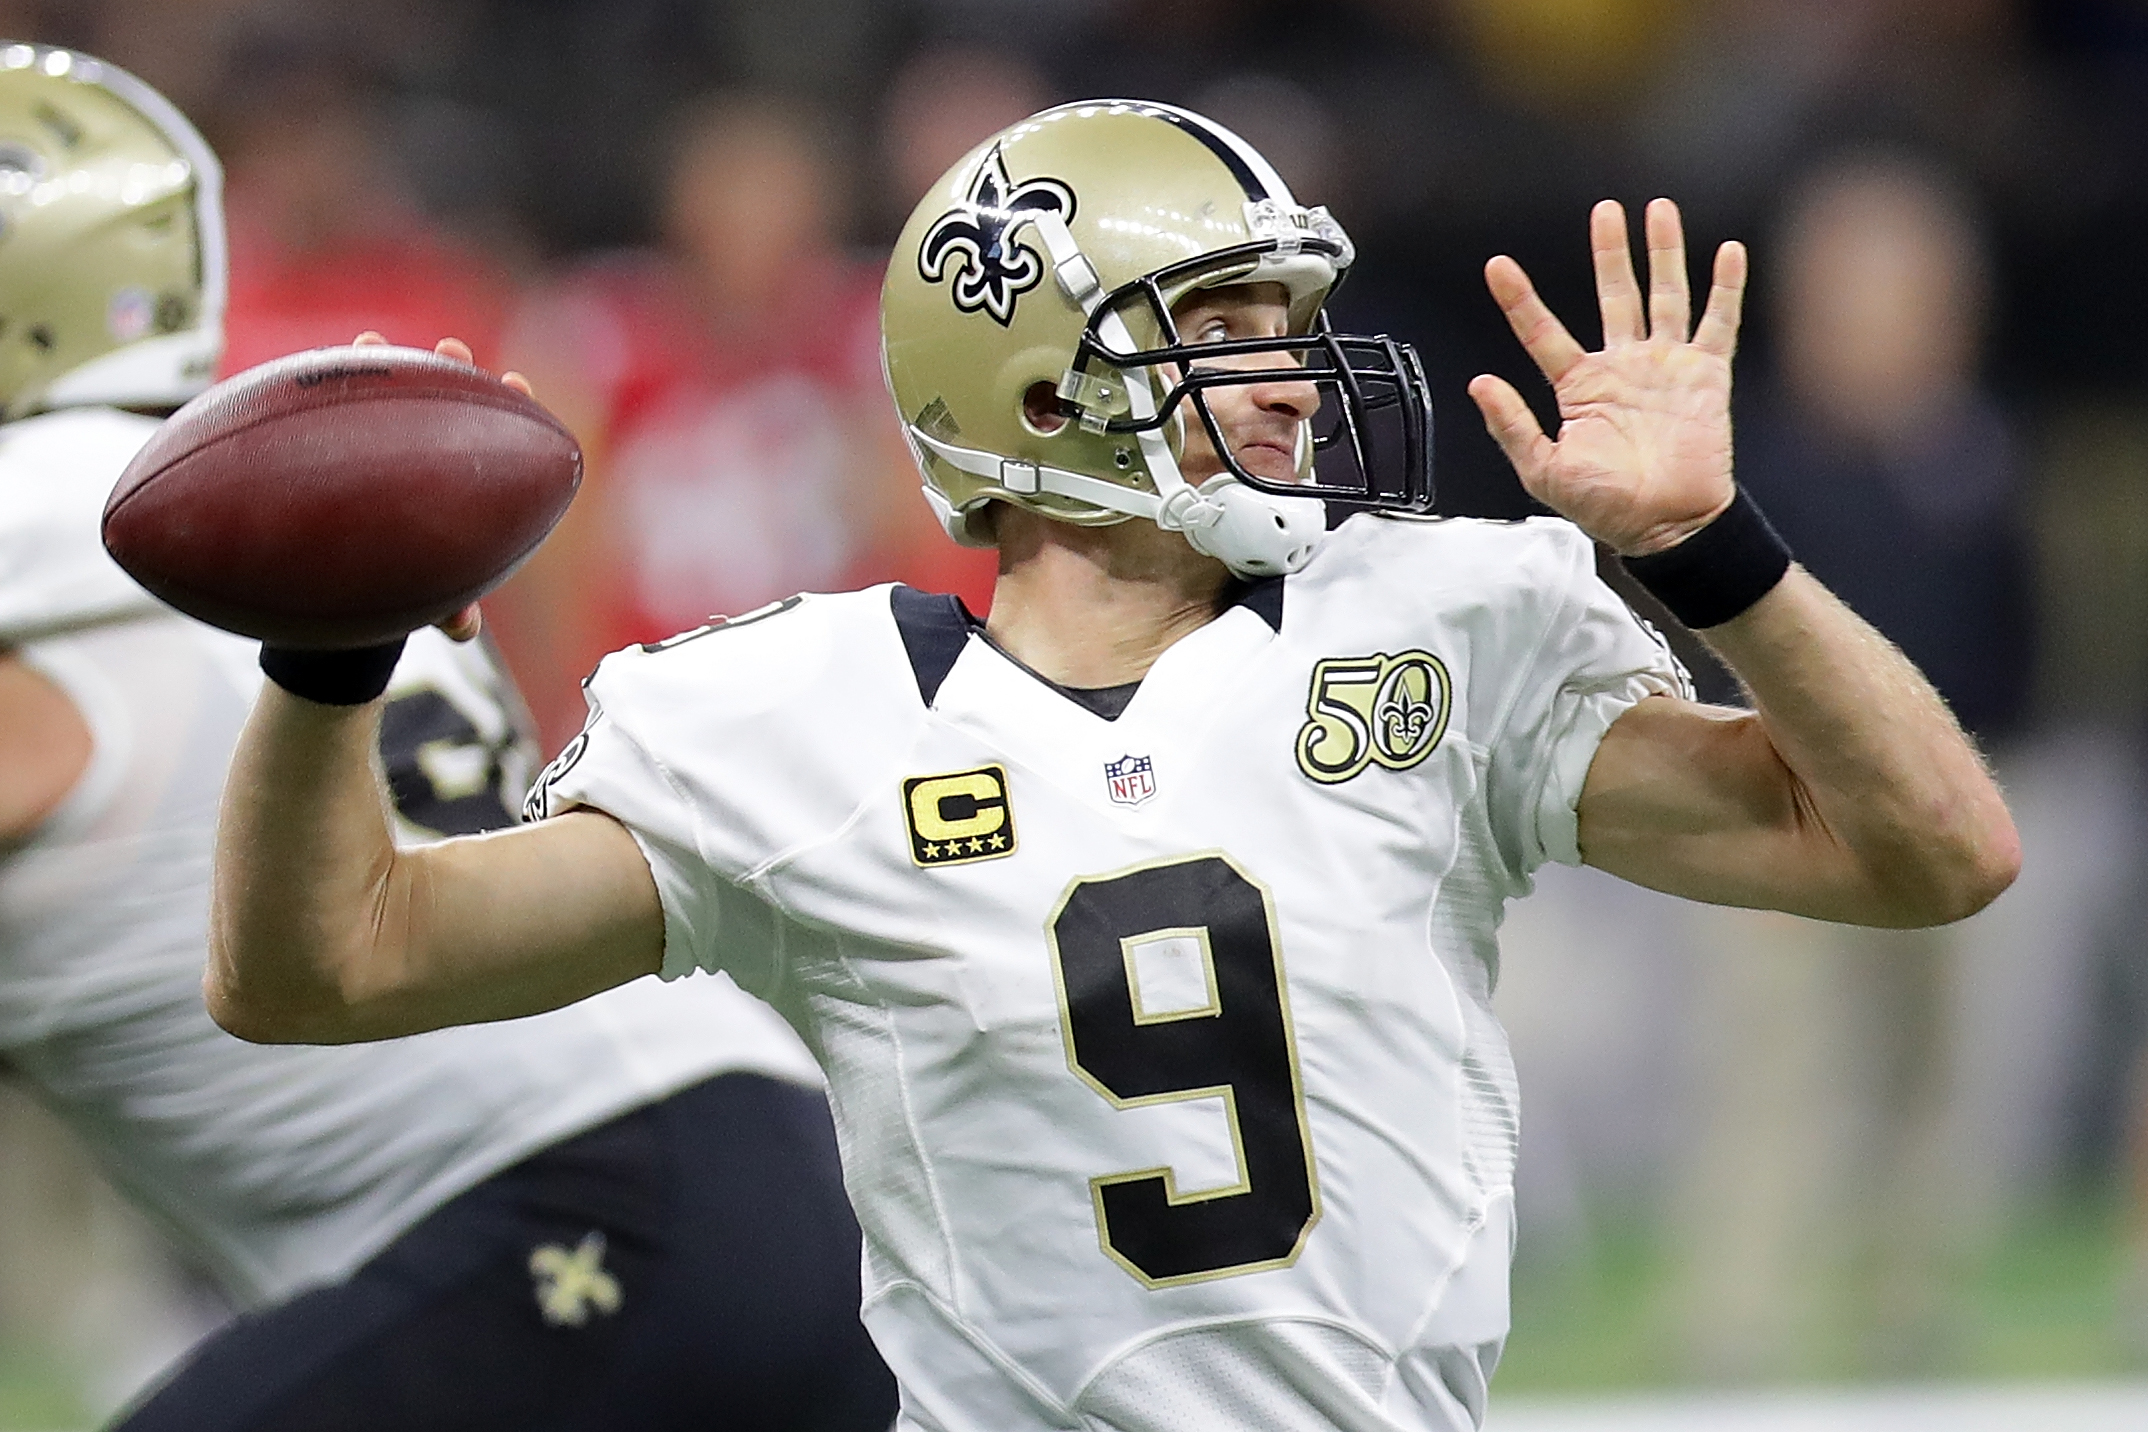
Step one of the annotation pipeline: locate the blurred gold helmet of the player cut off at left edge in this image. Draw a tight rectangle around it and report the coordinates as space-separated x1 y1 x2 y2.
0 41 226 419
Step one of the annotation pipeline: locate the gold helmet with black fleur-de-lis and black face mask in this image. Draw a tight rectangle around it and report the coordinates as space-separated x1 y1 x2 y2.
881 99 1433 575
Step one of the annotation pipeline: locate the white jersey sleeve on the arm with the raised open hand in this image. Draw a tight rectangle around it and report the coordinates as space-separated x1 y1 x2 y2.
1489 522 1693 876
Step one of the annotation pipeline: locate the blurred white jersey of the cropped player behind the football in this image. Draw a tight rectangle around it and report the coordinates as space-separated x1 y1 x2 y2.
0 410 818 1303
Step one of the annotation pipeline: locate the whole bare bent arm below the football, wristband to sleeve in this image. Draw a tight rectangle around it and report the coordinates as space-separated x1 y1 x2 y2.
204 685 664 1043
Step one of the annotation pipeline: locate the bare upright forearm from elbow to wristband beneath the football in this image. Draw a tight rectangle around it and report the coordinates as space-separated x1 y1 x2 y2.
204 683 414 1041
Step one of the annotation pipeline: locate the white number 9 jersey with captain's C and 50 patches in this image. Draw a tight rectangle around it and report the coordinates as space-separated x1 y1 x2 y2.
537 515 1684 1432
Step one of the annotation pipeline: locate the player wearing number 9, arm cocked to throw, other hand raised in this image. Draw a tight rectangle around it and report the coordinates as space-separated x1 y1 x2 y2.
208 101 2019 1432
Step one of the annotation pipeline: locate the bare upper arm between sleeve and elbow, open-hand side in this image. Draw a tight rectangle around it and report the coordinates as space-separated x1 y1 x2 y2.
1577 696 1858 917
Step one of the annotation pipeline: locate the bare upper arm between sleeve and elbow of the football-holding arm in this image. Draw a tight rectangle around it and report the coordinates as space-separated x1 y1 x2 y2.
357 812 664 1039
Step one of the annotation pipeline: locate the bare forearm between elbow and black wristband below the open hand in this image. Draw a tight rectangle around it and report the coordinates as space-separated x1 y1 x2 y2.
1703 567 2021 925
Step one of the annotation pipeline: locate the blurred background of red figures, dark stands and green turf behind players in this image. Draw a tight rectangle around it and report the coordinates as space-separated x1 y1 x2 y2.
0 0 2148 1428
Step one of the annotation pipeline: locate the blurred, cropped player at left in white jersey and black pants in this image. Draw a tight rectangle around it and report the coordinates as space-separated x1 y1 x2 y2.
0 43 896 1432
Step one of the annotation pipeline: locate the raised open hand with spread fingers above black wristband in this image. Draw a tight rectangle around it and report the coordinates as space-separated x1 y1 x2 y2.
1469 200 1746 556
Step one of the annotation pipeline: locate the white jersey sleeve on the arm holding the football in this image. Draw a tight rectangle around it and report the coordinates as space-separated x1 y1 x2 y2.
524 696 778 996
